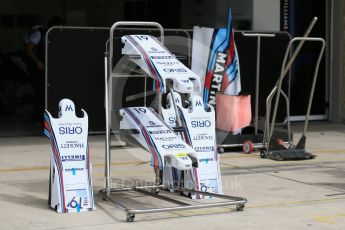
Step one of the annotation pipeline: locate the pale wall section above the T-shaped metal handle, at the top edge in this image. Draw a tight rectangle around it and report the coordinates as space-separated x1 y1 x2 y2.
253 0 280 31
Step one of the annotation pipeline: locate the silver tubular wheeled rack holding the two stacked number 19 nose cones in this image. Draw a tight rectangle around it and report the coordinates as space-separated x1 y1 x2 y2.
100 21 247 222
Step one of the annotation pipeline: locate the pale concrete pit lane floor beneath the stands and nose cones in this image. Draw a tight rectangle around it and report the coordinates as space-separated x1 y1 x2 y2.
0 124 345 230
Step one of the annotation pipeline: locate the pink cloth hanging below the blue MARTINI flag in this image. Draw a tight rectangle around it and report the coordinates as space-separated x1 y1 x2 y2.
216 93 252 132
